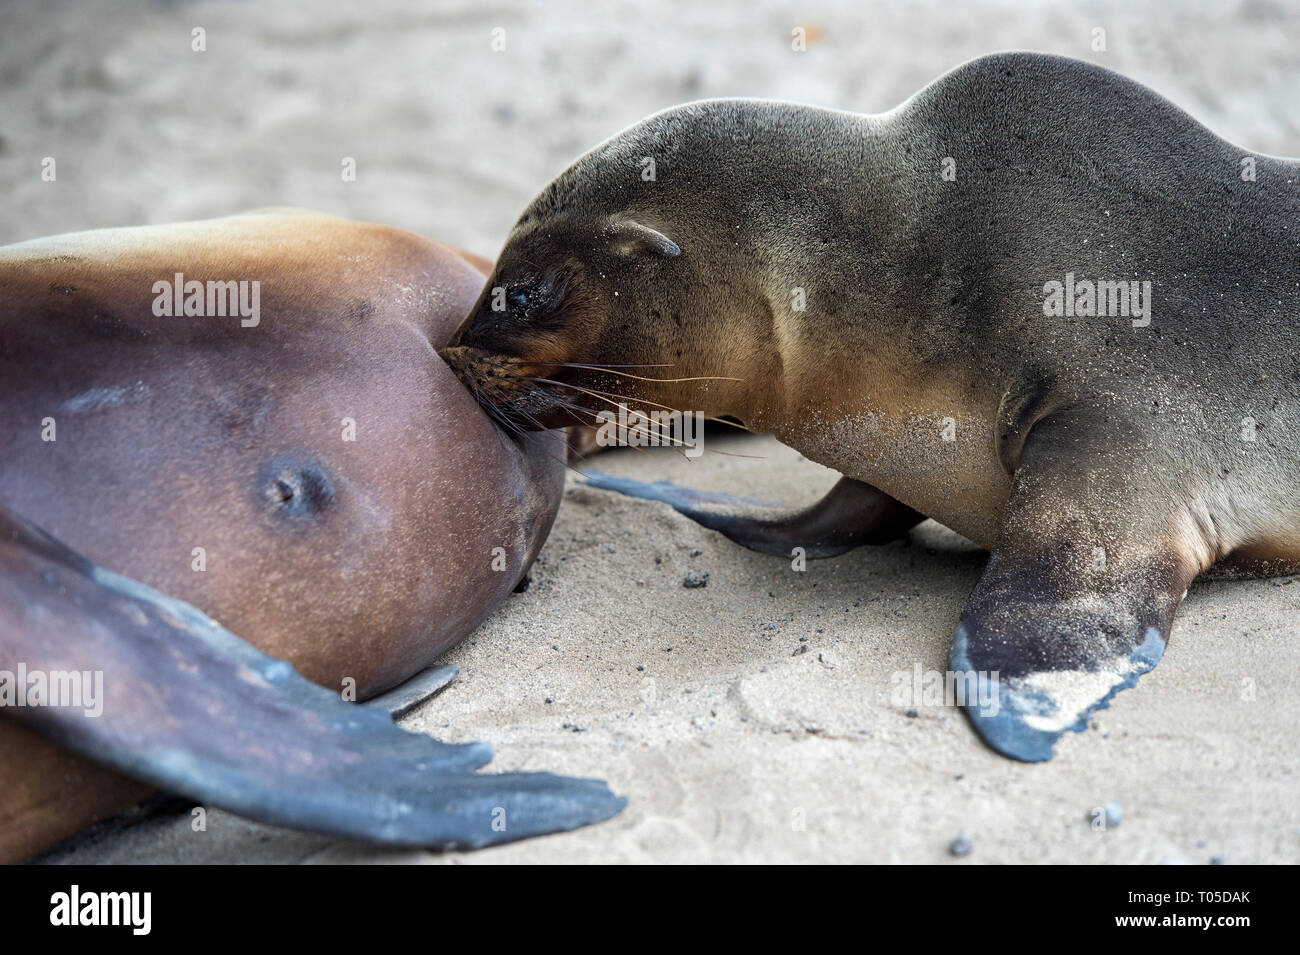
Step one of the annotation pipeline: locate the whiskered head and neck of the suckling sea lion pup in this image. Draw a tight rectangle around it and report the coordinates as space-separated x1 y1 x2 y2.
442 100 800 430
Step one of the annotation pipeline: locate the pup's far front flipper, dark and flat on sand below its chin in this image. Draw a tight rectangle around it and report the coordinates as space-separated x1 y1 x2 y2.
585 470 924 557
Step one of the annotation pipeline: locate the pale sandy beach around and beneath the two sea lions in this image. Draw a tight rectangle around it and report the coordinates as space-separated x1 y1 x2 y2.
0 0 1300 864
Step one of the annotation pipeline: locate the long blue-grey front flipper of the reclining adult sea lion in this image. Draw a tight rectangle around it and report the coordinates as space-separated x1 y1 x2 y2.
0 508 625 848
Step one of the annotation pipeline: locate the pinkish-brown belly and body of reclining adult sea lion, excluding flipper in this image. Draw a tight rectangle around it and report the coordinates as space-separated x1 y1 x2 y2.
0 210 564 860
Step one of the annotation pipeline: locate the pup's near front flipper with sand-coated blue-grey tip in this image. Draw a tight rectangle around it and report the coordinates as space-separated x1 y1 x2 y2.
950 409 1212 761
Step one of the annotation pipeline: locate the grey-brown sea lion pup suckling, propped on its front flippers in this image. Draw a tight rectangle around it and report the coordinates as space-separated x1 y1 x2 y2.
445 53 1300 760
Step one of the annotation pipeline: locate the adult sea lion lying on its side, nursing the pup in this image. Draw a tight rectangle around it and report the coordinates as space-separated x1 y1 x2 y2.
0 210 621 859
